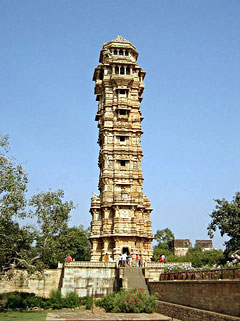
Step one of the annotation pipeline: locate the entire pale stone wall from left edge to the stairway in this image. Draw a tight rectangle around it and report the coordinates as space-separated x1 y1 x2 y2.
0 262 119 297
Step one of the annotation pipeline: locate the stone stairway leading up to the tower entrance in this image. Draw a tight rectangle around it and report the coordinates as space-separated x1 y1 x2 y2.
123 266 149 293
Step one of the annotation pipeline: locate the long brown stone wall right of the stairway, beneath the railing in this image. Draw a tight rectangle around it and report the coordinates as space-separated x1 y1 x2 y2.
148 280 240 319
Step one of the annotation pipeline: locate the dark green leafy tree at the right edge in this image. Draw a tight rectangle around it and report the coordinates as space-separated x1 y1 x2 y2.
208 192 240 253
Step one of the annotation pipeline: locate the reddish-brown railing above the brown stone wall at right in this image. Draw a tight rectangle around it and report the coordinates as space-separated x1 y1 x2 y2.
160 267 240 281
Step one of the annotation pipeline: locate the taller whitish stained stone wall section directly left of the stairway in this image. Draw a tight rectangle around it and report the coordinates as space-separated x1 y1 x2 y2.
61 262 118 297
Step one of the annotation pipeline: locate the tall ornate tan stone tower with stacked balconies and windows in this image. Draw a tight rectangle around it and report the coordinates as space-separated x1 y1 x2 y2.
90 36 153 262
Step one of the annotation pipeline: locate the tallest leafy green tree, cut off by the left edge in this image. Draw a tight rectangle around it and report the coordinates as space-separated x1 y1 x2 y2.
0 135 33 271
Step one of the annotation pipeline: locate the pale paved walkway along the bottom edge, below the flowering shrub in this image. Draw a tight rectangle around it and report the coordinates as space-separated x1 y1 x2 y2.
46 311 171 321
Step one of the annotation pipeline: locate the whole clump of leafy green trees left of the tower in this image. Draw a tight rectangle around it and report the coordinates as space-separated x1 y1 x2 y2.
0 135 90 272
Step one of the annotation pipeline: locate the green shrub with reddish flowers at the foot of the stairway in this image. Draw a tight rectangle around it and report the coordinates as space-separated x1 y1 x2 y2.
96 289 157 313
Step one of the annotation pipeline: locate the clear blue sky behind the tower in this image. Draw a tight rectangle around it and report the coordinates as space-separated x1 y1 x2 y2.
0 0 240 247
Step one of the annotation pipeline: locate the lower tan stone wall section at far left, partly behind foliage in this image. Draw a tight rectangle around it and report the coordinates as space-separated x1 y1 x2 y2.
0 268 62 297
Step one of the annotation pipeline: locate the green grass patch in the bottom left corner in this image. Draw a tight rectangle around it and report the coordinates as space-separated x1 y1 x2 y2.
0 311 49 321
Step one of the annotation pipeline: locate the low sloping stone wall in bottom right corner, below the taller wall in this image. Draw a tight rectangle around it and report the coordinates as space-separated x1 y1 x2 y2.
157 301 240 321
